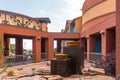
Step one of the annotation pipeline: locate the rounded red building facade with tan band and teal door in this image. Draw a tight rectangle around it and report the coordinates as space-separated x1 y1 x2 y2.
80 0 118 76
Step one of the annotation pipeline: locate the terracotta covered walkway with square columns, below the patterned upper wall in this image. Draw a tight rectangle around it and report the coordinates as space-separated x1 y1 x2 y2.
0 25 80 66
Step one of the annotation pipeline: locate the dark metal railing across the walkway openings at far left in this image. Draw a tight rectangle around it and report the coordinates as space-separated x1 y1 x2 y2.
4 54 35 66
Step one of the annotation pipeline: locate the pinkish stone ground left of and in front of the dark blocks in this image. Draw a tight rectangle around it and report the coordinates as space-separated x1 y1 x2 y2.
0 61 115 80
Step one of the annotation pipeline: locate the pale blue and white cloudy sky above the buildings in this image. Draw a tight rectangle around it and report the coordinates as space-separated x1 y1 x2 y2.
0 0 85 32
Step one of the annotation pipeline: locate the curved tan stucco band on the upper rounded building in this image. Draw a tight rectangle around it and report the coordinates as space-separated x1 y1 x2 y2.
82 0 116 28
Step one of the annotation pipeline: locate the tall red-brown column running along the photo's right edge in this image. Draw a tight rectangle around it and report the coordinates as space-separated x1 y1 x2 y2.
116 0 120 76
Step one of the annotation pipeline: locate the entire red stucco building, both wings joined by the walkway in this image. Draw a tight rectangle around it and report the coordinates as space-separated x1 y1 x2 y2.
0 0 120 75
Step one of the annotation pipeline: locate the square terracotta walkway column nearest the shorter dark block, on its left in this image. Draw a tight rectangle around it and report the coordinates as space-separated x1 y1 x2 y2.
48 37 54 60
